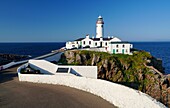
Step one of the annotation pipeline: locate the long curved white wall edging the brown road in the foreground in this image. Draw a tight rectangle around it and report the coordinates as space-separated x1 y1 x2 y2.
18 73 166 108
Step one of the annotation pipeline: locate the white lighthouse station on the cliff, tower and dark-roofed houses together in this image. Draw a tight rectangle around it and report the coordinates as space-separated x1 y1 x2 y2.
66 16 133 54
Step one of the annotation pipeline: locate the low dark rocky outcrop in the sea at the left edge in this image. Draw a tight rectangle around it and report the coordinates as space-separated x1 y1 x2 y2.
0 54 28 66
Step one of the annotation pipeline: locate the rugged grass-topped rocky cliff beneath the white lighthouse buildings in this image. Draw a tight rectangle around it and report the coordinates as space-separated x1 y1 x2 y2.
59 50 170 106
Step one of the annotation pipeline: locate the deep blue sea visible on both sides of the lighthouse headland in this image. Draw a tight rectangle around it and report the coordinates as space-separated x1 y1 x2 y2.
0 42 170 74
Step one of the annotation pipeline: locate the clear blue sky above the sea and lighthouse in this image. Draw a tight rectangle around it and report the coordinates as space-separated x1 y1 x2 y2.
0 0 170 42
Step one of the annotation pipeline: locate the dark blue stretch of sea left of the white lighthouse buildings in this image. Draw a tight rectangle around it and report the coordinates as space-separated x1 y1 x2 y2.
0 42 65 57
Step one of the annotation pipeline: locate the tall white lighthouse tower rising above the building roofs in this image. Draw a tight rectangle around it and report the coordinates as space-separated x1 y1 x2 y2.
96 16 104 38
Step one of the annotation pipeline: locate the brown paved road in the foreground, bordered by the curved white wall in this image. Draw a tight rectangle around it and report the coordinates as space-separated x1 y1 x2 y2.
0 67 115 108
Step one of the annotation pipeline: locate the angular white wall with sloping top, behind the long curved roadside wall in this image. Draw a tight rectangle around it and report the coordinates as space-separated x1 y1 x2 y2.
29 60 97 79
